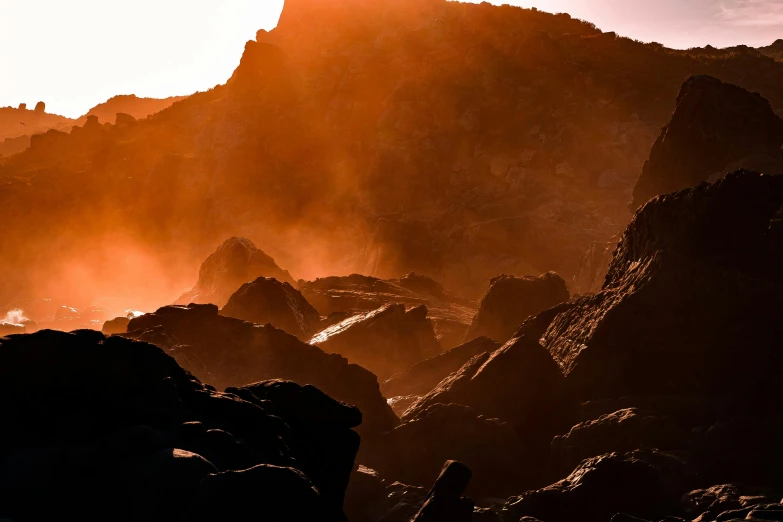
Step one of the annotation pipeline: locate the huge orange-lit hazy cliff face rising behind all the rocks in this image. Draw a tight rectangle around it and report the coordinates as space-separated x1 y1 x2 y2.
0 0 783 300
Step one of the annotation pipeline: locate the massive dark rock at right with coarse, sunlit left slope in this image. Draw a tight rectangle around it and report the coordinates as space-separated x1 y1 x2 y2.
543 172 783 398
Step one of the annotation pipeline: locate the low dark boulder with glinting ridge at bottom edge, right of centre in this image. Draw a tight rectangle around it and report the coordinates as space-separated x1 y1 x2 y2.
506 450 697 522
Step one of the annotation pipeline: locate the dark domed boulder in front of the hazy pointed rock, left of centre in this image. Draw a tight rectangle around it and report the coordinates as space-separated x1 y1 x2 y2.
220 277 321 339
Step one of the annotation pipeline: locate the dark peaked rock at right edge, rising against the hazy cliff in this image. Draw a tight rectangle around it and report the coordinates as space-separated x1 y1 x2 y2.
631 76 783 210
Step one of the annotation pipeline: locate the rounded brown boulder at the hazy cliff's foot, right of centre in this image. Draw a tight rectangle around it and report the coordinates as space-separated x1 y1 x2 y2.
465 272 570 343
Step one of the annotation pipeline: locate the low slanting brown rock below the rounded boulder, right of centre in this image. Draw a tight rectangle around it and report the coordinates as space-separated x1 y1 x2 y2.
381 337 500 397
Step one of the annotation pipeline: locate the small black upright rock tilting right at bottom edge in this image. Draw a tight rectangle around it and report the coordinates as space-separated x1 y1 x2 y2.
413 460 473 522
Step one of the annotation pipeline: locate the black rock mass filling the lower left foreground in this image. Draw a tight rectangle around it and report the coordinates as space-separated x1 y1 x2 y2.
0 331 361 522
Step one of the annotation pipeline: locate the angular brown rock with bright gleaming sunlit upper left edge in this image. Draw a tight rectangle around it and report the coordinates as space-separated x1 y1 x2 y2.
310 304 441 379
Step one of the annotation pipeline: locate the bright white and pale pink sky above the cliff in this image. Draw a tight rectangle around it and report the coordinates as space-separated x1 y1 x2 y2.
0 0 783 117
